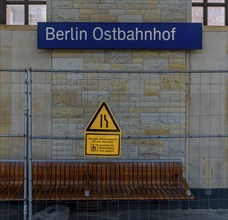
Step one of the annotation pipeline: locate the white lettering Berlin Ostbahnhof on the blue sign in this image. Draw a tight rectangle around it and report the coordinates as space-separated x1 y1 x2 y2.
46 27 177 41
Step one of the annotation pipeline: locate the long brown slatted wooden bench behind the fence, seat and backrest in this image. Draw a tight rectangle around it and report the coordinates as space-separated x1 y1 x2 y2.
0 160 194 201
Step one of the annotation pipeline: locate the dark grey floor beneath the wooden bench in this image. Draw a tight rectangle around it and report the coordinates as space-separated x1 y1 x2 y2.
0 203 228 220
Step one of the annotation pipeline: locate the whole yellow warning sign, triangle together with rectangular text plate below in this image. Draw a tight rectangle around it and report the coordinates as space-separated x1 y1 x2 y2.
85 101 121 157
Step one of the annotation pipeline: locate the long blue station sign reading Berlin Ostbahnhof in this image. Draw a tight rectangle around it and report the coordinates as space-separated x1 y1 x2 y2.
37 22 202 50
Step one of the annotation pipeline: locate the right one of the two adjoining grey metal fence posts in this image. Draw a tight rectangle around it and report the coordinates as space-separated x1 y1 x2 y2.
28 69 32 220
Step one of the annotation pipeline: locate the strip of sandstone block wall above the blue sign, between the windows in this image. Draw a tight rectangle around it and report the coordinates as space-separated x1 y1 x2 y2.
48 0 190 22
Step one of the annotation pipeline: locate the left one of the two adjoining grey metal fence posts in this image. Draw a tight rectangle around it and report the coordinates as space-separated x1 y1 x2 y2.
23 69 28 220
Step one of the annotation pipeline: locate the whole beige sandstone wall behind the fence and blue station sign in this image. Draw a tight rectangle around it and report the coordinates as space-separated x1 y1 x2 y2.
0 0 228 188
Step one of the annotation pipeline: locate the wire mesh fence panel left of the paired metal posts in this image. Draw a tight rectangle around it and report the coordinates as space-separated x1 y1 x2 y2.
0 70 25 219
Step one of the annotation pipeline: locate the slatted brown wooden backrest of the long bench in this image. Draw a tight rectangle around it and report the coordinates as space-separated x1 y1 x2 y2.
0 161 182 185
